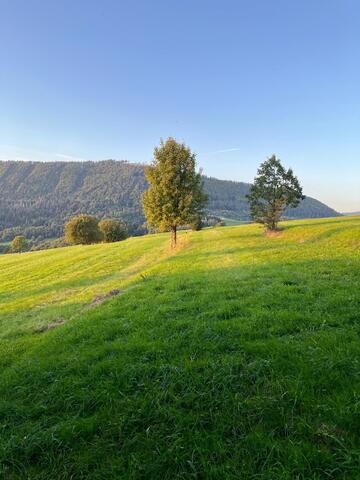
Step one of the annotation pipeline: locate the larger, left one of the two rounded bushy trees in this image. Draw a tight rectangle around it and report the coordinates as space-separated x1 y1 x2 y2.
65 214 102 245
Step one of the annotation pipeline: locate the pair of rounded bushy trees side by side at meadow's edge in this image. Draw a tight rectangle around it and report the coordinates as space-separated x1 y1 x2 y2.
65 218 128 245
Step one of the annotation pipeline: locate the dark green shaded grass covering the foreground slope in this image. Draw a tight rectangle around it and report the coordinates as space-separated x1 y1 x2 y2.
0 257 360 480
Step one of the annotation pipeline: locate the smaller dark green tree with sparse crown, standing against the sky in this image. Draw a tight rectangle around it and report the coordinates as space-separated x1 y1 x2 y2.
247 155 305 230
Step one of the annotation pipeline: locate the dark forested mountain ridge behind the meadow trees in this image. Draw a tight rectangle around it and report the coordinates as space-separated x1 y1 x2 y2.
0 160 339 242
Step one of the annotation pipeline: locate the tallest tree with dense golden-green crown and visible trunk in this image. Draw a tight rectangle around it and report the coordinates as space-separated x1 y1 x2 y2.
142 138 207 247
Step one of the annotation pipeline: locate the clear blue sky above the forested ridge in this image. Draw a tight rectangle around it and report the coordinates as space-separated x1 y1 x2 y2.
0 0 360 211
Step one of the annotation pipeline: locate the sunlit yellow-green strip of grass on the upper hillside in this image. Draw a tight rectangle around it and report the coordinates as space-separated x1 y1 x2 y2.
0 217 360 335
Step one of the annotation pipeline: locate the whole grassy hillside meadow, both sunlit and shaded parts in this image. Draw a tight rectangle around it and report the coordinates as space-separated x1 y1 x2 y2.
0 217 360 480
